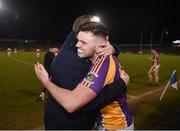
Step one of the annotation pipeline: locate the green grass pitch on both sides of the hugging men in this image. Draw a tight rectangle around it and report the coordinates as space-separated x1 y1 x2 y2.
0 52 180 129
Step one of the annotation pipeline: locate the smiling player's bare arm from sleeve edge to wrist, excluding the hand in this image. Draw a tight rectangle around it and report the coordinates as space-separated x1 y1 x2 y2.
44 81 96 113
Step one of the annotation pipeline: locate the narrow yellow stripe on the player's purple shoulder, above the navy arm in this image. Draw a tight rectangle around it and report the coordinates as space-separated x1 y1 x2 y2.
104 55 116 86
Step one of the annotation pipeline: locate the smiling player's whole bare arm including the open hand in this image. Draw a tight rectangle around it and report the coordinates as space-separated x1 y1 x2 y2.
34 63 96 112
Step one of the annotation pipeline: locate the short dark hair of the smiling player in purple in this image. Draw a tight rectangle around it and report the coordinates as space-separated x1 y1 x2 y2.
78 22 109 37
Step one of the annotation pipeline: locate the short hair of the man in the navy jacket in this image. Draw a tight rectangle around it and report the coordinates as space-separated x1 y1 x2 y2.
73 15 93 34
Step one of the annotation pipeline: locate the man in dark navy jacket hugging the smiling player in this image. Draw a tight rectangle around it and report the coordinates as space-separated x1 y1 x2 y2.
44 15 127 130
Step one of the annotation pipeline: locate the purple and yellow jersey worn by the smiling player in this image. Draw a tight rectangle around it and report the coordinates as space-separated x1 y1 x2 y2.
83 55 132 130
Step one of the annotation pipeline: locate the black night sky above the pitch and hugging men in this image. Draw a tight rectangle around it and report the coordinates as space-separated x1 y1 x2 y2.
0 0 180 44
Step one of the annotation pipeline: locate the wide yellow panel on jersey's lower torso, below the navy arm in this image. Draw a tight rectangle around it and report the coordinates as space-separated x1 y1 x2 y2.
100 101 127 130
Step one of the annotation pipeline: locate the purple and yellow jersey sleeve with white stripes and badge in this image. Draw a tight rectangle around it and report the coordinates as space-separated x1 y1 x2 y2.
82 55 116 94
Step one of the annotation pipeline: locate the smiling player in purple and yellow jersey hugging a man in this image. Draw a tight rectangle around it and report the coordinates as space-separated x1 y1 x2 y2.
35 22 133 130
